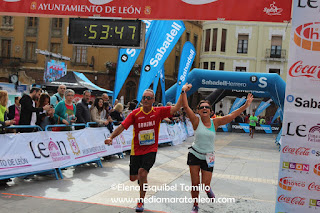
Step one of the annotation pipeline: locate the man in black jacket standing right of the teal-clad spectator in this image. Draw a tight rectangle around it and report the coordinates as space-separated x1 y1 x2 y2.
76 90 91 126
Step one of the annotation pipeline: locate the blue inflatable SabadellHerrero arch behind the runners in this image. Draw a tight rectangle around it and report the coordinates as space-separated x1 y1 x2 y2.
166 69 286 110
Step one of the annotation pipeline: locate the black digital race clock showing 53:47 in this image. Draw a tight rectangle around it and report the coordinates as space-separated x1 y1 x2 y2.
68 18 145 48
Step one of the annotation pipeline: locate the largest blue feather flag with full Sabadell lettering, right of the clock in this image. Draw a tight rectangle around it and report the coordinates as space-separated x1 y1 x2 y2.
137 21 185 102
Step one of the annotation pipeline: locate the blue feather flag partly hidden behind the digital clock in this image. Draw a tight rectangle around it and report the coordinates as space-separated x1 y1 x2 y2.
112 20 154 104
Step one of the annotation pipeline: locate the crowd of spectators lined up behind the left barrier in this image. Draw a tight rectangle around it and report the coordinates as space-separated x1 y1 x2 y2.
0 85 143 133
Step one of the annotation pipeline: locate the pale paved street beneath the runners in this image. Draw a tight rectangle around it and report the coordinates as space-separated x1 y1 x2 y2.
0 133 280 213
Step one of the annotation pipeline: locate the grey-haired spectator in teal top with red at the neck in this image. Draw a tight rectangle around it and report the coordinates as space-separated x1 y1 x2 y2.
54 89 77 125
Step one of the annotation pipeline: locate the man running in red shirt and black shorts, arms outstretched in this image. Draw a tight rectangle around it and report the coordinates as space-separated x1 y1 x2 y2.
105 84 191 212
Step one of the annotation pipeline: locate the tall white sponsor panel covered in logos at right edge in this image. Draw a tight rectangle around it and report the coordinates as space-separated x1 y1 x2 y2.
276 0 320 213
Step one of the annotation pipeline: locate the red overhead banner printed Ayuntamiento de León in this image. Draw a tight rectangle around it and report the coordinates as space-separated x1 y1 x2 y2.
0 0 292 22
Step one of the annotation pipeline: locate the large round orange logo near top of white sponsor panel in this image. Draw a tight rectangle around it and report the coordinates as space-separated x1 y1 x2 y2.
293 22 320 51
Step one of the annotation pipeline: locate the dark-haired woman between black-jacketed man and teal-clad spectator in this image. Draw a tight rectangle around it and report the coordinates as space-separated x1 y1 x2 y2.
36 93 56 130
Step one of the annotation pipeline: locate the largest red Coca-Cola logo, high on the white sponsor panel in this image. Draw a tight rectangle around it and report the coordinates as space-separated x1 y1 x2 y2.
289 61 320 80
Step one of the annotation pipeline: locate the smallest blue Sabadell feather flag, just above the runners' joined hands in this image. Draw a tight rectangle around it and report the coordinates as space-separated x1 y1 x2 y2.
176 41 196 103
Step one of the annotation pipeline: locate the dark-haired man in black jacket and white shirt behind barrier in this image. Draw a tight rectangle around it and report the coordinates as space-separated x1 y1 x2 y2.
19 87 50 132
